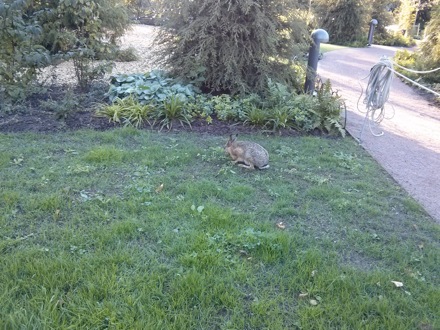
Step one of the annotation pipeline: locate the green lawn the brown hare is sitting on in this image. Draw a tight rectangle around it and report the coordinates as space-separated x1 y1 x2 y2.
0 128 440 329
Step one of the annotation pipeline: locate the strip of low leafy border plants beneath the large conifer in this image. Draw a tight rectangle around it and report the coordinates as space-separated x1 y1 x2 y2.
98 71 345 136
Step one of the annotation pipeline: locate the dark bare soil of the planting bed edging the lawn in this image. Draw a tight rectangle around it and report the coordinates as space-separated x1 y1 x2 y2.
0 86 302 136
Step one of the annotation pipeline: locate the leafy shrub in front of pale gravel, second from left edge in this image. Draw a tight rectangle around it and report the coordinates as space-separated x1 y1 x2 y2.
32 0 129 89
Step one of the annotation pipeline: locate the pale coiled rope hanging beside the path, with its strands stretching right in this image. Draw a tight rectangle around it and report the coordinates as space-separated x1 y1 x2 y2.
357 56 440 140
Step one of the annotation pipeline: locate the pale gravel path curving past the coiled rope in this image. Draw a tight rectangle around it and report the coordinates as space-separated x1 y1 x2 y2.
318 46 440 223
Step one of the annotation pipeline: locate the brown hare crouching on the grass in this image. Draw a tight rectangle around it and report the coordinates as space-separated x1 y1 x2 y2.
225 134 269 170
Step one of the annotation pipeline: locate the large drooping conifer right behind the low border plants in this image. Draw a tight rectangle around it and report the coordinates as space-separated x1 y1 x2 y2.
155 0 308 94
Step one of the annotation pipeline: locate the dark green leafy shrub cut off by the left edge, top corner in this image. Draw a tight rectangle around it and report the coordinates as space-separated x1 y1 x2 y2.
0 0 50 109
